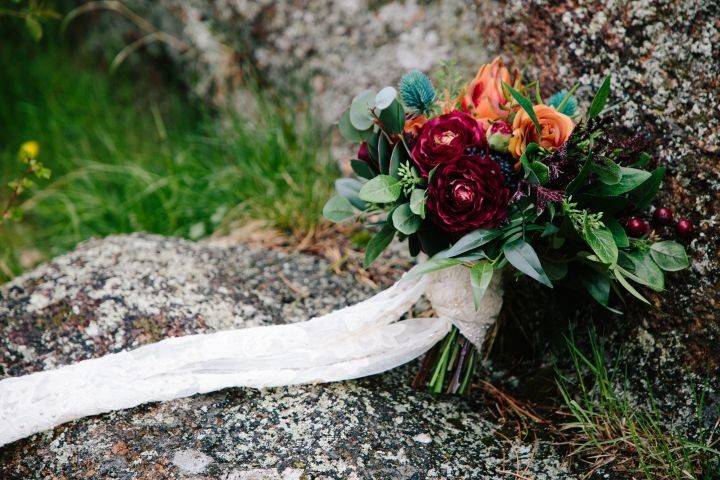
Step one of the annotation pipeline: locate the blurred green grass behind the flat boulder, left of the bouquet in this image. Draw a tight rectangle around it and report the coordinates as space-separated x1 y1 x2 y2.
0 34 336 280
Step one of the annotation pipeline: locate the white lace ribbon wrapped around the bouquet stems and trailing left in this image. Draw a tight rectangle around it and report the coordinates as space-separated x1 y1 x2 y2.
0 267 502 446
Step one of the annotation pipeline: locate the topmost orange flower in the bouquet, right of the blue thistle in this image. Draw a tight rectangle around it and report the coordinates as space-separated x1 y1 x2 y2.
460 57 520 126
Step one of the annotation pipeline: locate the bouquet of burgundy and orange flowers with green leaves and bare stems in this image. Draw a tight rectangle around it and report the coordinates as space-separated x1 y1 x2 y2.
323 58 693 394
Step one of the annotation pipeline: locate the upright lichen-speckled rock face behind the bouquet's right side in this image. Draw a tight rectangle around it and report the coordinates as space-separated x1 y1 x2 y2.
485 0 720 412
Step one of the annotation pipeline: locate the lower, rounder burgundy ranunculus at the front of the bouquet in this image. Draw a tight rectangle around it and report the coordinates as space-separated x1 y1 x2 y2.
427 155 510 235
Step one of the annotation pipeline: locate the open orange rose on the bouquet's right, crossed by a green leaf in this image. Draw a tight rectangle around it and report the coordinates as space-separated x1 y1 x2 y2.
508 105 575 158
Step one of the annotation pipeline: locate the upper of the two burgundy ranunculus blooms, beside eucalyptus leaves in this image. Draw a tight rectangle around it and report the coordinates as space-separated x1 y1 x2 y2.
412 111 487 176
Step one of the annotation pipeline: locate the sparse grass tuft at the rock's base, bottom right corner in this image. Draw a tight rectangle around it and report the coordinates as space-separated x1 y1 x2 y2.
558 335 720 480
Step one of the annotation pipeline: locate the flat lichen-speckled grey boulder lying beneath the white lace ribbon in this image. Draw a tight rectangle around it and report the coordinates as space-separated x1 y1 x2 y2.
0 235 572 480
